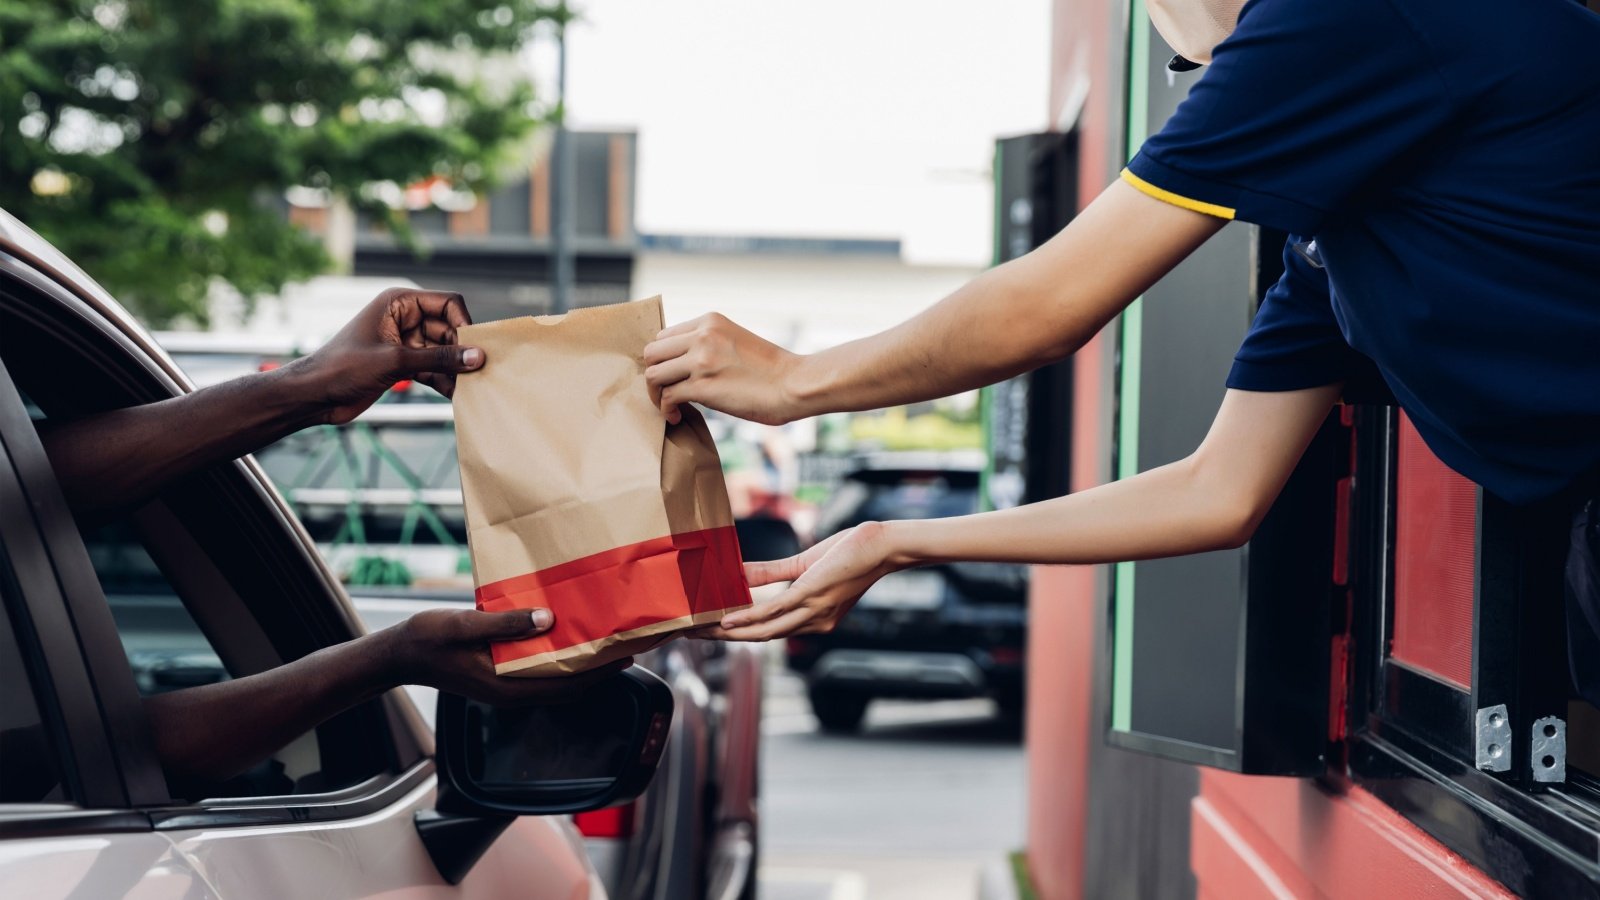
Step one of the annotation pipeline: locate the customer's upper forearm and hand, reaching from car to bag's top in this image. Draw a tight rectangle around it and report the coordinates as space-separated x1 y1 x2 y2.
38 288 483 519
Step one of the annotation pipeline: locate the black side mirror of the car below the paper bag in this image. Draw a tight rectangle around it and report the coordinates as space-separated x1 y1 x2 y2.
416 666 674 884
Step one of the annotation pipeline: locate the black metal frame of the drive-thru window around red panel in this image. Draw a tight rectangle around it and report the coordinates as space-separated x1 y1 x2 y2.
1346 407 1600 895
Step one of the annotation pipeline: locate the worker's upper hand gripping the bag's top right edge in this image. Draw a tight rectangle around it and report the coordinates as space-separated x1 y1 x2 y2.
645 312 803 424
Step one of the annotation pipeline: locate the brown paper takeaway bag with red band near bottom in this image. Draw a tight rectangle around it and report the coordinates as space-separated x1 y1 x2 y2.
454 296 750 677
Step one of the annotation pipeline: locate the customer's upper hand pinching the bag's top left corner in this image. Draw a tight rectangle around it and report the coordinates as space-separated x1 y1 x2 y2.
298 288 483 424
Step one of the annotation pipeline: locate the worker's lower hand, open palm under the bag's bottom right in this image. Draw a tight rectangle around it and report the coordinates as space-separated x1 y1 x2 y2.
696 522 904 641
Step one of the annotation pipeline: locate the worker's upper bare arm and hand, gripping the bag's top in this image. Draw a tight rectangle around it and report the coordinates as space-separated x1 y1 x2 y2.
645 181 1224 424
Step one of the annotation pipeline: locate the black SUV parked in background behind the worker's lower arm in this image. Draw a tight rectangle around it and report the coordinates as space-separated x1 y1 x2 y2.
787 453 1027 733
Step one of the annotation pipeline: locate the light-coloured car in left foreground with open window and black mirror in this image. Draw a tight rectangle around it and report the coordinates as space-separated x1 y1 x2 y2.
0 211 672 900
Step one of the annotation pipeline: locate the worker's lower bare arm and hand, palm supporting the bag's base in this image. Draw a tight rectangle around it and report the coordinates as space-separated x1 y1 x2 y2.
706 384 1339 641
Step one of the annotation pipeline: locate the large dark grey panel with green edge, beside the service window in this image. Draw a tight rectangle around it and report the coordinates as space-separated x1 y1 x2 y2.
1107 31 1347 775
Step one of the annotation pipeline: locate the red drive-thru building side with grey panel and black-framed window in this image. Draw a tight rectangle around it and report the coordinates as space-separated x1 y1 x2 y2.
1002 0 1600 897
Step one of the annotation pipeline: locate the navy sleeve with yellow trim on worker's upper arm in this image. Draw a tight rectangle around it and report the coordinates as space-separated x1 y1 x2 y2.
1122 0 1454 234
